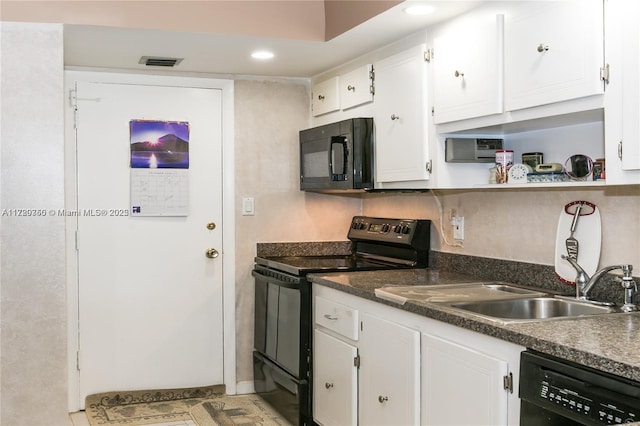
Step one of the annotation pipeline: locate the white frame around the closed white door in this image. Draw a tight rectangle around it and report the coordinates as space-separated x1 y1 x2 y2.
64 71 237 412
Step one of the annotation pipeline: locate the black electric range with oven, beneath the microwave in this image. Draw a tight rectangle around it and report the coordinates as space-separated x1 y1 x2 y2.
252 216 431 425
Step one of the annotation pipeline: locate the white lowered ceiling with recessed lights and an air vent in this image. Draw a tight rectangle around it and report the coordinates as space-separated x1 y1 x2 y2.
64 0 481 78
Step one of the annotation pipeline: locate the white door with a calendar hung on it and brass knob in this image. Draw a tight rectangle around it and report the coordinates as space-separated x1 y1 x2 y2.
74 82 223 408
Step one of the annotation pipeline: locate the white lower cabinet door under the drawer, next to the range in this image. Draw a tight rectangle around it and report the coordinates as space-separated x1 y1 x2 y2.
313 330 358 426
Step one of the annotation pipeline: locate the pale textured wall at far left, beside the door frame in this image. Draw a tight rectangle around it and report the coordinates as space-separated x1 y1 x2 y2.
0 23 67 426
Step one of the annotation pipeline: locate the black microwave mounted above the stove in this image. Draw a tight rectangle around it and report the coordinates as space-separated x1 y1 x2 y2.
300 118 374 192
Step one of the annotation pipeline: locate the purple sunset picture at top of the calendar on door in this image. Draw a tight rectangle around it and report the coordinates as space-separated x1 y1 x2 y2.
129 120 189 169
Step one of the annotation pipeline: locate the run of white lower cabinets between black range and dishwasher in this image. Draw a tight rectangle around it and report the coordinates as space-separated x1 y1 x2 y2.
313 285 525 426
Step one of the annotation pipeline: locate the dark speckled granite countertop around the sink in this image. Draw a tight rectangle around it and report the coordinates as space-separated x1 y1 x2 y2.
310 269 640 381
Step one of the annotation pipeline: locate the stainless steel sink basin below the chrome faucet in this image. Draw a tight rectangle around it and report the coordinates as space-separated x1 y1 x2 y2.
449 297 620 322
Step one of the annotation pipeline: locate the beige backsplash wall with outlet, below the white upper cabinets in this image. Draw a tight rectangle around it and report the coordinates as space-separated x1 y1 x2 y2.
363 185 640 268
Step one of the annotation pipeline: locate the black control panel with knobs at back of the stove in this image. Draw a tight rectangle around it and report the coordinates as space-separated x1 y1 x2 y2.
348 216 431 248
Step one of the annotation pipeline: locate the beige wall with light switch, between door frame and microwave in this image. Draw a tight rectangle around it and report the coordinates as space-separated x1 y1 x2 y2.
235 80 361 382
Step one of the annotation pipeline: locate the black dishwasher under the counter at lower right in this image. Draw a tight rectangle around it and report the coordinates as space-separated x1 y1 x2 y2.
520 351 640 426
